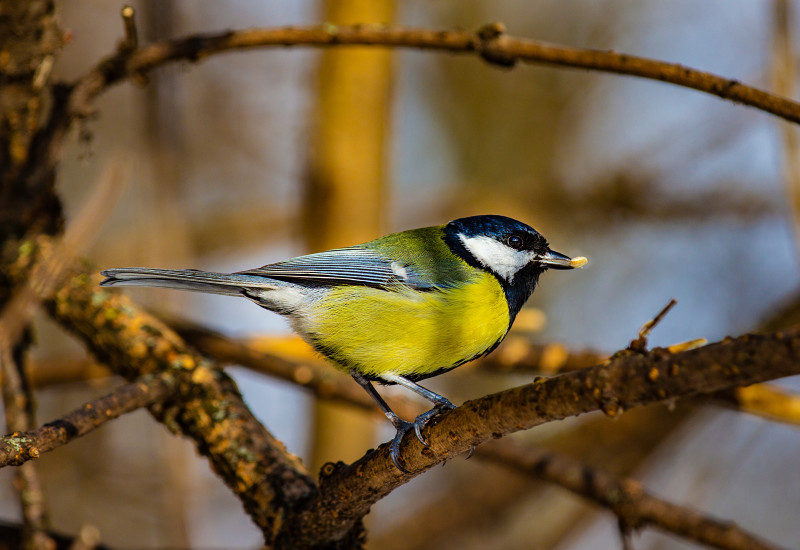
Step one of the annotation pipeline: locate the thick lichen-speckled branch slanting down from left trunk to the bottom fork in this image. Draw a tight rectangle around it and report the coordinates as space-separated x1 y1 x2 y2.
11 238 315 543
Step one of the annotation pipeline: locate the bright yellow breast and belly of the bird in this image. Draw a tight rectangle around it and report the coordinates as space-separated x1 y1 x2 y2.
303 270 509 377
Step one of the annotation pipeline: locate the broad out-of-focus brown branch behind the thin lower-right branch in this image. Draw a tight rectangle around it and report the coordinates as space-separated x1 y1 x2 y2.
370 403 697 550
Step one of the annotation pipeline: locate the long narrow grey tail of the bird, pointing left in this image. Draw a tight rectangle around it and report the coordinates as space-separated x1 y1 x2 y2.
100 267 275 296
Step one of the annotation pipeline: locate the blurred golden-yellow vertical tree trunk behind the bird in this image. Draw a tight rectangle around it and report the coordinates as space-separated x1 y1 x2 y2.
304 0 395 471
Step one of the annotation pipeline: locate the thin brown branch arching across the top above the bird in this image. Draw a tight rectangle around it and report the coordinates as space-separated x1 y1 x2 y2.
68 23 800 135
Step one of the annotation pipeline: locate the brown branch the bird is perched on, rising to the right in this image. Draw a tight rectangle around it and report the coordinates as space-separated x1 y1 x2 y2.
289 328 800 544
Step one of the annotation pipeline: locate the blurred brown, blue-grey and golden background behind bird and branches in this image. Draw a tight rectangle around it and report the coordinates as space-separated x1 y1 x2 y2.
0 0 800 550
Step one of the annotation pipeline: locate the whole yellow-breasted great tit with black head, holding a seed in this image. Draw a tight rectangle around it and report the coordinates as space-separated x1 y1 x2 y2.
100 215 586 471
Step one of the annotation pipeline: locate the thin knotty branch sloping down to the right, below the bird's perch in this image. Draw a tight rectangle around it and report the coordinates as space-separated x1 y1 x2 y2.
477 441 776 550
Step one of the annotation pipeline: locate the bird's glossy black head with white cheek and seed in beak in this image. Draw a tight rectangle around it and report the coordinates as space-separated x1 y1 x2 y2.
444 215 586 315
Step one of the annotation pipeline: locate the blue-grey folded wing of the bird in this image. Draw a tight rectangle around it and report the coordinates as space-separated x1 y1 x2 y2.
239 246 433 289
